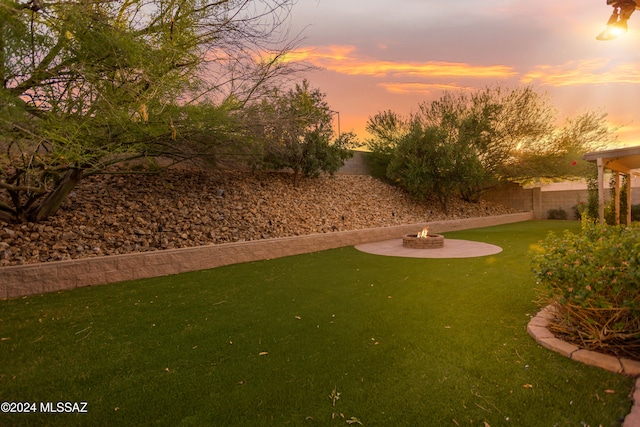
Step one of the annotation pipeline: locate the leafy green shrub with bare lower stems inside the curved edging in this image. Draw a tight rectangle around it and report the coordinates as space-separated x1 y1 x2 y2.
532 221 640 360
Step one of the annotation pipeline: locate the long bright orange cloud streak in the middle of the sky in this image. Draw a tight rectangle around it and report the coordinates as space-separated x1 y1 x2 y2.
285 46 516 78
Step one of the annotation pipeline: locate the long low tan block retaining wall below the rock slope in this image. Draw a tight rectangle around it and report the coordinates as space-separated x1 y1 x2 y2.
0 212 533 299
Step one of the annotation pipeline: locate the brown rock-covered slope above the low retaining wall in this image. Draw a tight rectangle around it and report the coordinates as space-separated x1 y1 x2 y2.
0 170 514 266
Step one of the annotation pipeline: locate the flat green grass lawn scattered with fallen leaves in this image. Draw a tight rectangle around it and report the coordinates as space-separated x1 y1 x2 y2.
0 221 633 427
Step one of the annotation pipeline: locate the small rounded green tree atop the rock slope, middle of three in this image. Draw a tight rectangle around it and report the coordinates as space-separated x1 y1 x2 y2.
247 80 355 186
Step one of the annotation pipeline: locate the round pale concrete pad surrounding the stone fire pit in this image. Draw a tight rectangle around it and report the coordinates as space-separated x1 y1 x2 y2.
355 239 502 258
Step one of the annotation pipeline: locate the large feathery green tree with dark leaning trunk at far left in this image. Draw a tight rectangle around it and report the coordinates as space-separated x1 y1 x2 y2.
0 0 295 221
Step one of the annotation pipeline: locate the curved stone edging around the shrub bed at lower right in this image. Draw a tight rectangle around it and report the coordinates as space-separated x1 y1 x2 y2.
527 305 640 427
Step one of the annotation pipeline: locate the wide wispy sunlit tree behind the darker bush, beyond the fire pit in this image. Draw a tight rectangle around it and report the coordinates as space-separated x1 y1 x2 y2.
369 87 614 206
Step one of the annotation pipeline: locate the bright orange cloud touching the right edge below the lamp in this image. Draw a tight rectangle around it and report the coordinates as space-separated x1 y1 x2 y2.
521 59 640 87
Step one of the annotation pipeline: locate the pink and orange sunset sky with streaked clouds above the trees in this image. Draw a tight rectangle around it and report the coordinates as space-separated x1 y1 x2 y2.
291 0 640 146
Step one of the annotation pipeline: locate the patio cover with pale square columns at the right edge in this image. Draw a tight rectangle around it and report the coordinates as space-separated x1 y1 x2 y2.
583 146 640 224
